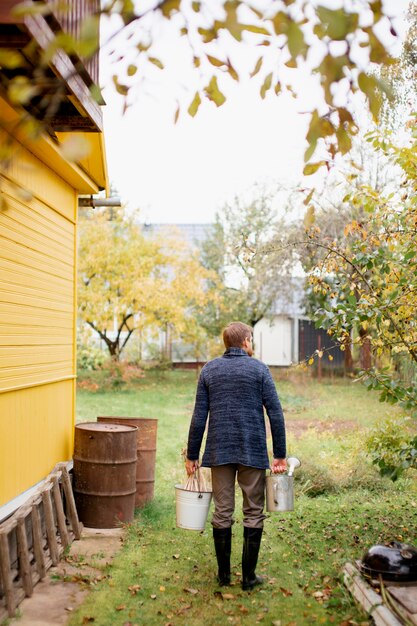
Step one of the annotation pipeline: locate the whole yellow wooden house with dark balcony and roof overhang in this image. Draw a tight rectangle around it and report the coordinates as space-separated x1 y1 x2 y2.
0 0 108 522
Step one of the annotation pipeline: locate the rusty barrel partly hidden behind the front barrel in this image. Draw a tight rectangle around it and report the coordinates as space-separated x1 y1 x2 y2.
97 417 158 507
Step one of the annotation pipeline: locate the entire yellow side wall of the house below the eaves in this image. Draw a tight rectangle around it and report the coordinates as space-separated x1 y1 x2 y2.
0 136 77 506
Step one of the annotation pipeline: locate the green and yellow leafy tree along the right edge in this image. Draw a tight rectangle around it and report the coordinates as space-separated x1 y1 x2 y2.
278 129 417 479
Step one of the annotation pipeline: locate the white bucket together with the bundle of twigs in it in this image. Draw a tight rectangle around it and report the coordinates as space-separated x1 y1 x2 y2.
175 448 211 530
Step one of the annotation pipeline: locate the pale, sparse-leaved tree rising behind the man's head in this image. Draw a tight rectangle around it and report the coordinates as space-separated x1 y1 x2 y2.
198 187 293 335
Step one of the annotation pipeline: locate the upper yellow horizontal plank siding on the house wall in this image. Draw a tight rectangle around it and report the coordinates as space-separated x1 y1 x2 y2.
0 197 75 391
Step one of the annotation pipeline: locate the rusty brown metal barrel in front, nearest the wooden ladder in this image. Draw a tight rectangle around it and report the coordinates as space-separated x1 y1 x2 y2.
74 422 137 528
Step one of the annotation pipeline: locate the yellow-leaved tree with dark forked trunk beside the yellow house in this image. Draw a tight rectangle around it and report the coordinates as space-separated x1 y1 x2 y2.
78 209 216 360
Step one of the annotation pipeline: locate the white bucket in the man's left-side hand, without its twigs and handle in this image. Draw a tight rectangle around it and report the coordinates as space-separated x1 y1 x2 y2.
175 485 211 530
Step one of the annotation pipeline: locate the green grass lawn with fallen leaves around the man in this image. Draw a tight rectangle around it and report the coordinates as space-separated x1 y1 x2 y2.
69 371 417 626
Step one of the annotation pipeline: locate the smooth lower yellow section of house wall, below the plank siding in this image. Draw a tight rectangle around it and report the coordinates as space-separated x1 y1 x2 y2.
0 380 74 506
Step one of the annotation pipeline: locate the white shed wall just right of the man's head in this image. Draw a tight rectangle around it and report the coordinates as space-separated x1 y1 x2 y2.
253 315 294 367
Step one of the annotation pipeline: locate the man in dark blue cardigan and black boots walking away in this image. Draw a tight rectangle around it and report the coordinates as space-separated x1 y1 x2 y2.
185 322 287 591
